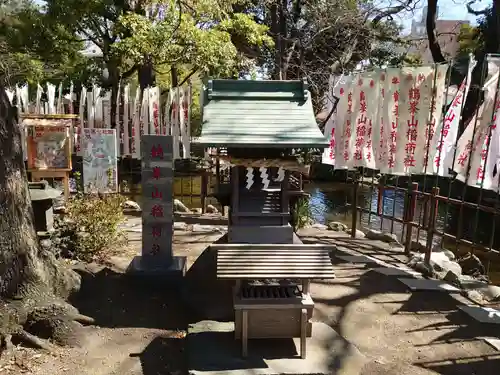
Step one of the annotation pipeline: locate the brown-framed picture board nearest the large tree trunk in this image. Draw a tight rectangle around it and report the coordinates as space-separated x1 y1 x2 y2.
23 119 72 171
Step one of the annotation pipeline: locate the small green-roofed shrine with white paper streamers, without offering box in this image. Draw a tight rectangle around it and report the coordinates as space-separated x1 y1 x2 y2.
198 80 328 244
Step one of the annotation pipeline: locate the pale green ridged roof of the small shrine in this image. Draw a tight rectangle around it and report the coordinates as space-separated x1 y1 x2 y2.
197 80 328 148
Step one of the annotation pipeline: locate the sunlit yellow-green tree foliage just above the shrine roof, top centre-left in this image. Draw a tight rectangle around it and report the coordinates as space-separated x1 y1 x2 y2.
111 0 272 76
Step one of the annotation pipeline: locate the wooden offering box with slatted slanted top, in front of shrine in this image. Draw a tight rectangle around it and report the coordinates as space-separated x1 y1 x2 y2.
211 244 335 358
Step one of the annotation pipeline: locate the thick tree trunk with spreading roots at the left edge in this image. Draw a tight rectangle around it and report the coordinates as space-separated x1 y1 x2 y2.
0 86 80 352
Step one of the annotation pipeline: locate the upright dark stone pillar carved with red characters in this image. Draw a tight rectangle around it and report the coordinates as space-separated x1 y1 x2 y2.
140 135 174 262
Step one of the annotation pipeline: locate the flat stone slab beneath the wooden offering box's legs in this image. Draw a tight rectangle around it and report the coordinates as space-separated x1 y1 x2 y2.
187 320 366 375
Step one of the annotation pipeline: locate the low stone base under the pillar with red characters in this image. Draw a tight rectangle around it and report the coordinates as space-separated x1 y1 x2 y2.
127 256 187 280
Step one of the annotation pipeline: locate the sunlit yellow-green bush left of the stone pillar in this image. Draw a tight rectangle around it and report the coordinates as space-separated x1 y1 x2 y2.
56 193 126 261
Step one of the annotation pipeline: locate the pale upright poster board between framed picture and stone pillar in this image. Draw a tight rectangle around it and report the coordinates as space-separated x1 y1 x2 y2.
80 129 118 193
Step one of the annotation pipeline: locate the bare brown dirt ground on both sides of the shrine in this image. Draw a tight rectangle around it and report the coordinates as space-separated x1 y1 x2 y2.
0 219 500 375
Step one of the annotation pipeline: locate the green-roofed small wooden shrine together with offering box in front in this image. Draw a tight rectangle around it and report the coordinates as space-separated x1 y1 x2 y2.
199 80 334 358
